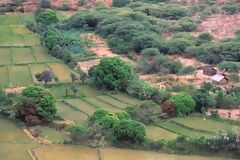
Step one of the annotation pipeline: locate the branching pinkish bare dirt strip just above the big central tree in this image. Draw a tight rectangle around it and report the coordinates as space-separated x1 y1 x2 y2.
77 33 135 72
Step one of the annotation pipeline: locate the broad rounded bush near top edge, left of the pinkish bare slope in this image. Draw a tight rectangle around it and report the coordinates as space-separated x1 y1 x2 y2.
161 5 188 20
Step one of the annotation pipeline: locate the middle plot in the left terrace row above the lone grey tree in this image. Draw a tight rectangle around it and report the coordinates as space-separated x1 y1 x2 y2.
12 48 37 64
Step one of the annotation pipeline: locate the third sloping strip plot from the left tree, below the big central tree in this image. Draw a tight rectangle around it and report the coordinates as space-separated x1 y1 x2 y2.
84 98 120 113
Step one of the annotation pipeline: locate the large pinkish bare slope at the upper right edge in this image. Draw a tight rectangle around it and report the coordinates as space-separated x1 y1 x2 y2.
194 14 240 40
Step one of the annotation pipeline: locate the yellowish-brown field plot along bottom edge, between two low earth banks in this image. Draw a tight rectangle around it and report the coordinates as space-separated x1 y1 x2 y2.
37 145 98 160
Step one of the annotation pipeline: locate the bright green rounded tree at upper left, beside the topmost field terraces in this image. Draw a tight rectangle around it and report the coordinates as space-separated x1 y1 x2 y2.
36 9 59 26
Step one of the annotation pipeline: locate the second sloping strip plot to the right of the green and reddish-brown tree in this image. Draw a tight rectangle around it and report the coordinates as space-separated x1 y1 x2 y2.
66 99 97 115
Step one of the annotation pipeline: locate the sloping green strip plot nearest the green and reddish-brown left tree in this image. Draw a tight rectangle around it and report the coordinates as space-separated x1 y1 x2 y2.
56 102 88 125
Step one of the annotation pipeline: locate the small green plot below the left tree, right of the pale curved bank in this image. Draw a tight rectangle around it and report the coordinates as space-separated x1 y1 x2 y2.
32 126 67 143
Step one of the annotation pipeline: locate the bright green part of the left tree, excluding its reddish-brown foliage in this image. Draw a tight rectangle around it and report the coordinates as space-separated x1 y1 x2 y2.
19 86 57 122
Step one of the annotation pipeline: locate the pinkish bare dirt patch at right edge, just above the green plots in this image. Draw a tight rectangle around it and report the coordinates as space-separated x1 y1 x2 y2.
207 109 240 121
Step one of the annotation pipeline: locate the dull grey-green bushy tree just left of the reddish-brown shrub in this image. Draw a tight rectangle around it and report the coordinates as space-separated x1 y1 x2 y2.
126 101 161 124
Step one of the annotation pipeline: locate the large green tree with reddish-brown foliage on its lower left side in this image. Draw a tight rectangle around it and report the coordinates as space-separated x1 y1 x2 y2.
17 86 57 124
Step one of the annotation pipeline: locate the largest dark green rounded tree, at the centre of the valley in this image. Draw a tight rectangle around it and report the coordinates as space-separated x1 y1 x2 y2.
89 57 133 90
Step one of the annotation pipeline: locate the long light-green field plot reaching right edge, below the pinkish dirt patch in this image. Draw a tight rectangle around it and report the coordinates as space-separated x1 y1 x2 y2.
173 116 240 133
